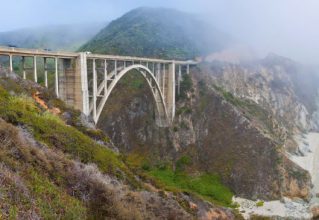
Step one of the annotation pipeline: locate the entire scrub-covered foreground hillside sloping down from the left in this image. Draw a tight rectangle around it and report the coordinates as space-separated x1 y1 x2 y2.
0 69 240 219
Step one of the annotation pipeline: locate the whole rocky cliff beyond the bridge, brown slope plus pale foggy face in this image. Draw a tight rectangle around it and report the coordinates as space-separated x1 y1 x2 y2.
98 57 316 199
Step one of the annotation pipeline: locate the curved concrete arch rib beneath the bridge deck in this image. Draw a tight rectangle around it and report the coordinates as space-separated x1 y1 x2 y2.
94 64 170 127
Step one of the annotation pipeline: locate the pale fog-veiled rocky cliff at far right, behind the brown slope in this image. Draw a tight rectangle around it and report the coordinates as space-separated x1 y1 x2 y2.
203 54 319 150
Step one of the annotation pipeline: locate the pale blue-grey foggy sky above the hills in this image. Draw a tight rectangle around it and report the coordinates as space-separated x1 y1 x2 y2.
0 0 319 63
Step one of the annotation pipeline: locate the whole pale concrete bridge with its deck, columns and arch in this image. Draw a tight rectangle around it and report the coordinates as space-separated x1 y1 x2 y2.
0 47 197 127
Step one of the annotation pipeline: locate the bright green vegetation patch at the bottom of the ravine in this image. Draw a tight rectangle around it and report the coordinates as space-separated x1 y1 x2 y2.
127 153 233 206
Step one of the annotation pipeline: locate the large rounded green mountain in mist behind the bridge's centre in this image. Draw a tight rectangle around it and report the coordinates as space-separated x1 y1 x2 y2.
80 8 232 59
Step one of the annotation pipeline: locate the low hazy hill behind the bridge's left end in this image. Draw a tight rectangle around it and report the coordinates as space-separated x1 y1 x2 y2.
0 23 105 51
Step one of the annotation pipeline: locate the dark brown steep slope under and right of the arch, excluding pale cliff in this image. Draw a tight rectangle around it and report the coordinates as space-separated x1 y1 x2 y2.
98 63 311 199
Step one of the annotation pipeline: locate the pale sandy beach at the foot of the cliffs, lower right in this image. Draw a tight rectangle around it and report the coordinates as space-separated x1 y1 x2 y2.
233 132 319 219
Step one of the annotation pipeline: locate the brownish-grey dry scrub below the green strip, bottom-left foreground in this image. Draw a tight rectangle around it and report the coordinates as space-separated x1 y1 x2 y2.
0 120 179 220
